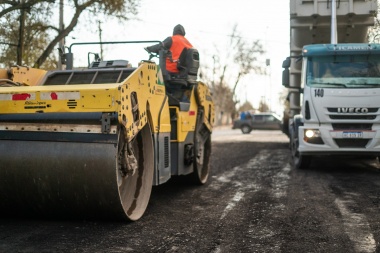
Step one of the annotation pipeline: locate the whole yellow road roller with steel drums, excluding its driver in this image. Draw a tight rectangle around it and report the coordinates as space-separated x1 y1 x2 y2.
0 41 214 220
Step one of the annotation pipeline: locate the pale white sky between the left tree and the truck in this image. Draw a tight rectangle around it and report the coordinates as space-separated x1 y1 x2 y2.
65 0 289 115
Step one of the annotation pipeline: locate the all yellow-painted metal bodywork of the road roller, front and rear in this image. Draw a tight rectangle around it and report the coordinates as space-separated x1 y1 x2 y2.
0 62 214 142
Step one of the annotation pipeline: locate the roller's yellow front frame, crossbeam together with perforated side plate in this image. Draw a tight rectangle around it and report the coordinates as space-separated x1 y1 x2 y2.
0 62 171 138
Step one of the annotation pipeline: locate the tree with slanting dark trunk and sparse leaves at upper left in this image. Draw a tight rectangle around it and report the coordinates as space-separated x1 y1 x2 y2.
0 0 140 67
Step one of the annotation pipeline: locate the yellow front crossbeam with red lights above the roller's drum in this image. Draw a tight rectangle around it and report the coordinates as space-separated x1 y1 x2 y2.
0 84 120 114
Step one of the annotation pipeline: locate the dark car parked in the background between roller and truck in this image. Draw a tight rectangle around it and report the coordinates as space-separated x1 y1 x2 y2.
232 113 282 134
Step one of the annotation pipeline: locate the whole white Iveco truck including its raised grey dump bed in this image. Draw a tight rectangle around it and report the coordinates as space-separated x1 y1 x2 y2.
283 0 380 168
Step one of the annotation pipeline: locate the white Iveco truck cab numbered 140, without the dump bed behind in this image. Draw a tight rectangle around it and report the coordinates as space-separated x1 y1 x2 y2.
284 44 380 167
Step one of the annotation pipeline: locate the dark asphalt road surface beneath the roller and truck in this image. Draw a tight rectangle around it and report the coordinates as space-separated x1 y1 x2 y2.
0 129 380 253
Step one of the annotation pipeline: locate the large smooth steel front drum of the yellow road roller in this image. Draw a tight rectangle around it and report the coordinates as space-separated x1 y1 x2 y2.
0 125 153 220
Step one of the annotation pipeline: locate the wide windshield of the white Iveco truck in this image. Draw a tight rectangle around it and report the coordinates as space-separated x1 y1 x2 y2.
306 55 380 88
